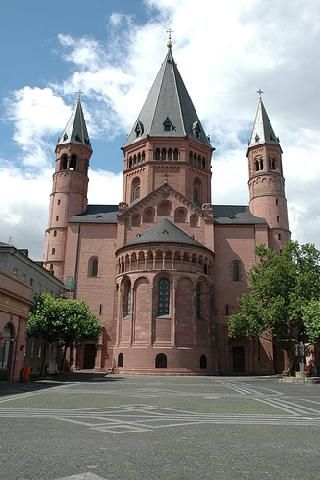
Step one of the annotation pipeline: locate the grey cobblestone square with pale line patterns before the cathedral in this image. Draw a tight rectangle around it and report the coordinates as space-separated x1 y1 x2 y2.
0 374 320 480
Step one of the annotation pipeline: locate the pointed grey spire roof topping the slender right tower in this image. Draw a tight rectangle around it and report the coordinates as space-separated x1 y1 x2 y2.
248 93 279 147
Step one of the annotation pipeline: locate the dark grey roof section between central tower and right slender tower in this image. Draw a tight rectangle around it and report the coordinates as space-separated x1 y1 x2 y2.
212 205 267 225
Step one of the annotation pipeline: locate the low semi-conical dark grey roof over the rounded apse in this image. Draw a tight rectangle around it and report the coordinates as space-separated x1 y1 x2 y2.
126 218 204 247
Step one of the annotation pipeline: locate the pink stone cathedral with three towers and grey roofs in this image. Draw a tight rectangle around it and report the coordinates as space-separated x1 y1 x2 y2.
44 40 290 375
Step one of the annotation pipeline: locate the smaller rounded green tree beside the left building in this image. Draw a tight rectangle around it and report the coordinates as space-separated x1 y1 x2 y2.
28 293 101 375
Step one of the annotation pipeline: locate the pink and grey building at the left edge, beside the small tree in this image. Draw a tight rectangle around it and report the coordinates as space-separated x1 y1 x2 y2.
0 242 64 382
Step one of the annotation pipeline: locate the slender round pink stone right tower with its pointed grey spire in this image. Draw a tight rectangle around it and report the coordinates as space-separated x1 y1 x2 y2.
247 94 290 248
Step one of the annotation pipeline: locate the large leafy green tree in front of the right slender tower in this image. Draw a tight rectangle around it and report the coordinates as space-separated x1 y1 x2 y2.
228 241 320 374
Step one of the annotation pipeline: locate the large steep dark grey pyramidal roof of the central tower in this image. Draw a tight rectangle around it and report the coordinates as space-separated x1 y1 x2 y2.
125 48 210 146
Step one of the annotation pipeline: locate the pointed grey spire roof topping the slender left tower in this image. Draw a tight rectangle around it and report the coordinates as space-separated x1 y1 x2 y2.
58 97 91 148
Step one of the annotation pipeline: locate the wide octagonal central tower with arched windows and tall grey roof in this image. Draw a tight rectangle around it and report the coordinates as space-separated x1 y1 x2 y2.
123 39 213 207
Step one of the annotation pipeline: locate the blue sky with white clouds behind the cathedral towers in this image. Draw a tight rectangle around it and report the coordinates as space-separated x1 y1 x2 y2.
0 0 320 260
